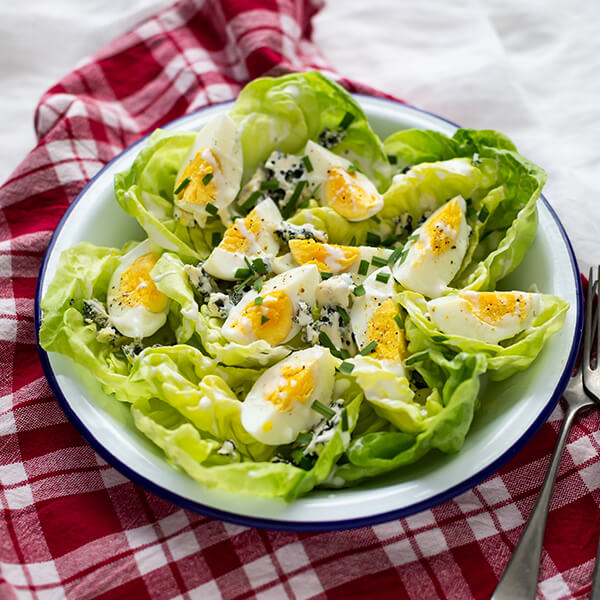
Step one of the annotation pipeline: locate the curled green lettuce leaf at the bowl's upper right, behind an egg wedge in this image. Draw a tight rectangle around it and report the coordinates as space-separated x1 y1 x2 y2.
381 129 546 290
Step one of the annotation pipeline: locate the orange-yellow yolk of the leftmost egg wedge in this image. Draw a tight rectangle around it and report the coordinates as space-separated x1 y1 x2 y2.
115 252 169 313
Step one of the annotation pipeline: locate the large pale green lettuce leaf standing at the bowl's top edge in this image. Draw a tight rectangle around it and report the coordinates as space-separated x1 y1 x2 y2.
230 71 390 191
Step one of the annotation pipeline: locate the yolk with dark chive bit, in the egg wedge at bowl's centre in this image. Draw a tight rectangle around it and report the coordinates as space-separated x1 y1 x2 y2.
232 290 294 346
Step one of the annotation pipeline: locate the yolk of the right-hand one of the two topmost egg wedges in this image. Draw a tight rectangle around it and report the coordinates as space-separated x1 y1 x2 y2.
325 167 379 219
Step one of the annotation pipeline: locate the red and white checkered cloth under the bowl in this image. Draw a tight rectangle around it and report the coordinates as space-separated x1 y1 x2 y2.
0 0 600 600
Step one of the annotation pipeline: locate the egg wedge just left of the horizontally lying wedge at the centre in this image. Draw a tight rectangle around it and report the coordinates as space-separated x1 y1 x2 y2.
203 199 281 281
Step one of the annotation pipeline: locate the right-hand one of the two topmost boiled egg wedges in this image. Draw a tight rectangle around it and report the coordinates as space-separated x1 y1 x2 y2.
305 140 383 221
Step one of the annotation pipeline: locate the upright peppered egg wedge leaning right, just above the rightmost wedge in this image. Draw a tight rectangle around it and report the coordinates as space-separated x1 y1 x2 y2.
393 196 471 298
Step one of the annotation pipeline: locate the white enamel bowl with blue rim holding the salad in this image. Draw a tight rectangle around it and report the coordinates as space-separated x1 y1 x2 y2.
36 96 582 531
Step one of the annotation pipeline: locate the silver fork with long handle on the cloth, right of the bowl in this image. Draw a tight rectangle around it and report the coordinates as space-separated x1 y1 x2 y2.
492 267 600 600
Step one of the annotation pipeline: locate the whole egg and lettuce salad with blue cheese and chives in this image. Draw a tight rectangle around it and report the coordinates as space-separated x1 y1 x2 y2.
39 72 568 501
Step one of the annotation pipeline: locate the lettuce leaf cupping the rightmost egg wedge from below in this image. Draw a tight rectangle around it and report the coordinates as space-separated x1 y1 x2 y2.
398 292 569 381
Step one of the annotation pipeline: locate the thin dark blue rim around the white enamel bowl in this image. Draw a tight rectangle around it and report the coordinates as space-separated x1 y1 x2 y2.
34 94 583 532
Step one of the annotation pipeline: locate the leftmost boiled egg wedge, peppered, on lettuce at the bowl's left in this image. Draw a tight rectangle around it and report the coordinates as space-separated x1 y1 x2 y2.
106 240 169 339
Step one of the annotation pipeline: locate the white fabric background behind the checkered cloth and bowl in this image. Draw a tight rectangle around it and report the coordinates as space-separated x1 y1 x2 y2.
0 0 600 270
